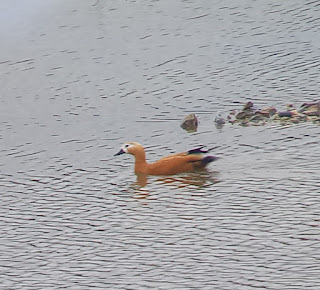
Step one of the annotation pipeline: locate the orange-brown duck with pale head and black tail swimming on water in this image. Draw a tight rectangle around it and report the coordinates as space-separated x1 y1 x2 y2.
115 142 219 175
